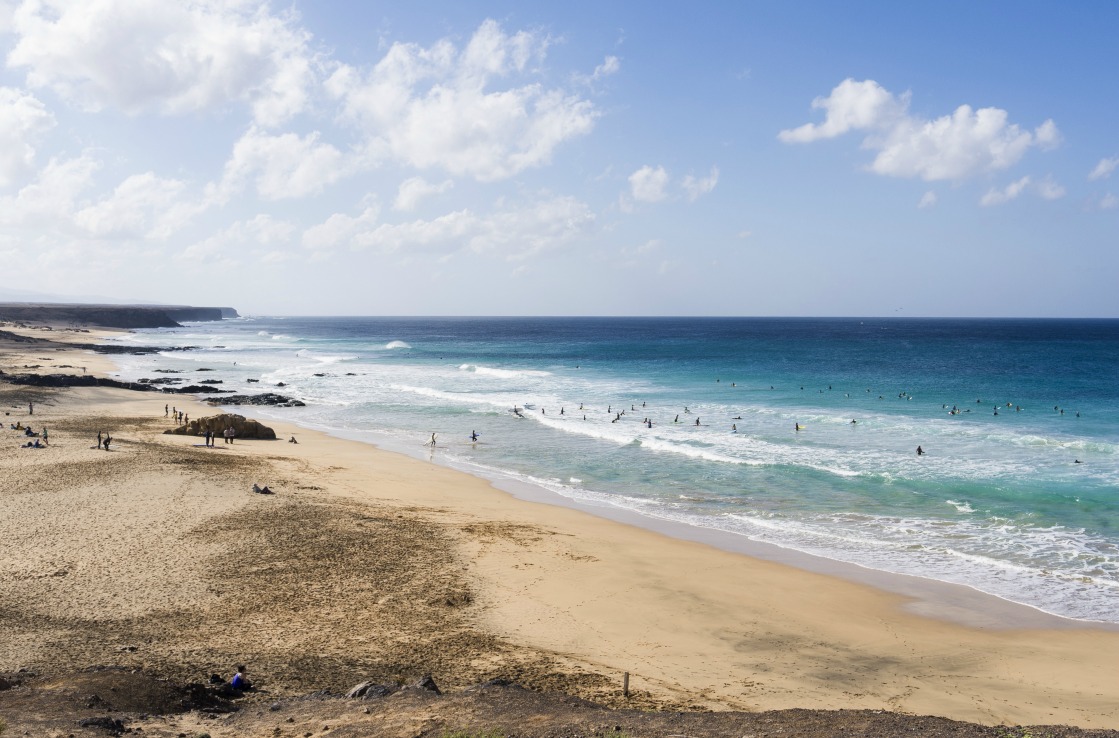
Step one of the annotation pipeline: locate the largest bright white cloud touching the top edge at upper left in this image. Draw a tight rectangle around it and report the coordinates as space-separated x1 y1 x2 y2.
8 0 312 125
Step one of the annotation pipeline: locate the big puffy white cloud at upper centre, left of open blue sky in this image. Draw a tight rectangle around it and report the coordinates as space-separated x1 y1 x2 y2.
326 20 598 181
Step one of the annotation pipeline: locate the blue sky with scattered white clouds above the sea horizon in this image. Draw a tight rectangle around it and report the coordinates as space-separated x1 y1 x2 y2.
0 0 1119 318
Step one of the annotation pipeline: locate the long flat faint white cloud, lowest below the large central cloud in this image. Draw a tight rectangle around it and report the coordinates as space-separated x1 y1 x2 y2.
303 197 594 259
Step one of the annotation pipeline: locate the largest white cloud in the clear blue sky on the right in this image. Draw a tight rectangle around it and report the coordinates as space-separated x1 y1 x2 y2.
778 79 1061 181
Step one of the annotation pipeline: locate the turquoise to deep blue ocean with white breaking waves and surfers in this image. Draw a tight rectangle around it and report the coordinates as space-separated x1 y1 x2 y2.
109 316 1119 623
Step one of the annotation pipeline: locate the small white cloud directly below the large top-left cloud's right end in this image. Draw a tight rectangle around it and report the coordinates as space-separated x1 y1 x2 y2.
211 127 344 201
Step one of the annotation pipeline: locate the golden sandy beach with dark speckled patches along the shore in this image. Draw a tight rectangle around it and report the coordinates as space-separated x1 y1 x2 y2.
0 328 1119 736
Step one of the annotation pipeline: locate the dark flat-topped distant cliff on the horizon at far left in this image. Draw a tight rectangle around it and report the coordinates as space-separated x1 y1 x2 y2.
0 302 238 328
